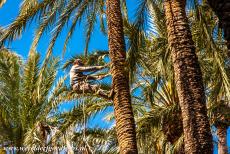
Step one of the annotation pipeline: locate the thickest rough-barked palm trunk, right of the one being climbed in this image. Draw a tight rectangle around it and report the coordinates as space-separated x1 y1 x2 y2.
164 0 213 154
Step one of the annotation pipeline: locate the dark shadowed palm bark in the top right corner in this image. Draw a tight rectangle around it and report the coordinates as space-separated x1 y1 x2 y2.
208 0 230 57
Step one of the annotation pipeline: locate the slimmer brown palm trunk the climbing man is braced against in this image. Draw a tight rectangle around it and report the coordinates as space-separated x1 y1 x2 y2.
106 0 137 154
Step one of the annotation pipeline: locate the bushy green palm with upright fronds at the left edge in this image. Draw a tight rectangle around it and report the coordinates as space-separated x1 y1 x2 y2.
0 49 68 152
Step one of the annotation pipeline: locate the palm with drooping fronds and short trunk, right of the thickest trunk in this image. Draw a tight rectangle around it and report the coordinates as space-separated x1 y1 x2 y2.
190 3 230 153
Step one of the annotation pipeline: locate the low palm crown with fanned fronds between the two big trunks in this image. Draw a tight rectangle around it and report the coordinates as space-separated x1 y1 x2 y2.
134 78 184 154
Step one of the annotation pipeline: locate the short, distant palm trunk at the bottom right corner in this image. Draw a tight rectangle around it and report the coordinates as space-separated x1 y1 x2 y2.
216 125 228 154
